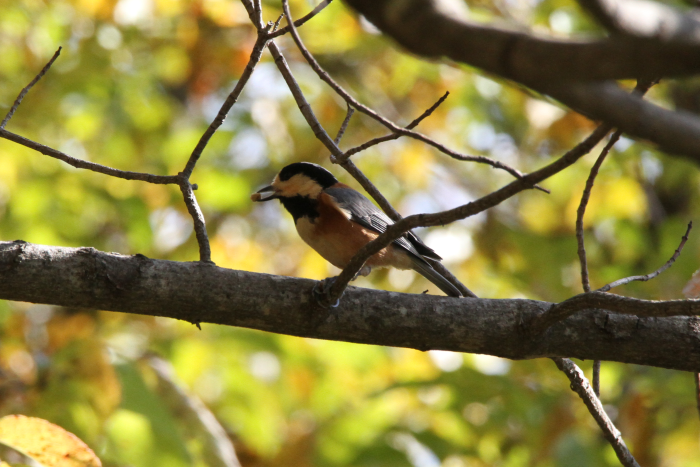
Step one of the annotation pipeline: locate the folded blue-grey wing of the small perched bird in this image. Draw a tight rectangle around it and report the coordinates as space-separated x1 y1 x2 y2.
325 187 442 261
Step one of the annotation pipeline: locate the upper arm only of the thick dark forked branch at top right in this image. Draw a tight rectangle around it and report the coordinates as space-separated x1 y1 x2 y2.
345 0 700 84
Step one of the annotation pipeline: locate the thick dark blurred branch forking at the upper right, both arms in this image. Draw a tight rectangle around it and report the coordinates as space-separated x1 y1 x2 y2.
346 0 700 162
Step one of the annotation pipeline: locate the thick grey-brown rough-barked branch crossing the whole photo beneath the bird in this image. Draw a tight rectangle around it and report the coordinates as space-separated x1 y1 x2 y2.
0 241 700 372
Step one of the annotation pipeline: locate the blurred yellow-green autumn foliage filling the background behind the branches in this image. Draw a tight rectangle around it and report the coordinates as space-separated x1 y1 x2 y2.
0 0 700 467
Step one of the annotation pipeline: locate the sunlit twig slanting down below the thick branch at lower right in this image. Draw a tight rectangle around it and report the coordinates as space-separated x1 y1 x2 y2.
552 357 639 467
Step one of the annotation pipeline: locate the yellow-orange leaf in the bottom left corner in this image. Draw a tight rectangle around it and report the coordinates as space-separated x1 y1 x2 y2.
0 415 102 467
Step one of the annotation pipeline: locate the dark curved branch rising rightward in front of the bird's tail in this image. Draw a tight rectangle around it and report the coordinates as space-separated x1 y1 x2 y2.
328 123 611 303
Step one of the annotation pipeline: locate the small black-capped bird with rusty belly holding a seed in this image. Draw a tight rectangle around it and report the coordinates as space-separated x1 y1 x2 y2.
250 162 462 297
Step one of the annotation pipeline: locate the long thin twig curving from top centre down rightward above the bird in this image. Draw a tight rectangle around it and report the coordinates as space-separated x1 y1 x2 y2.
282 1 546 188
